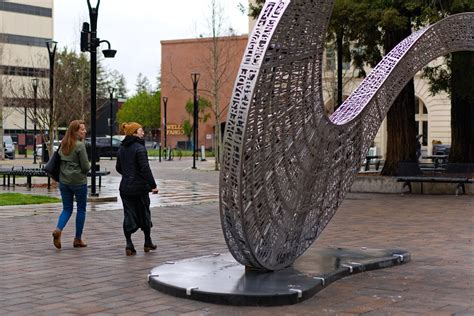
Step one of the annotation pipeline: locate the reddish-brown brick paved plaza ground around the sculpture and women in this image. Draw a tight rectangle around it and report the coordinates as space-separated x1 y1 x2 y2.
0 160 474 315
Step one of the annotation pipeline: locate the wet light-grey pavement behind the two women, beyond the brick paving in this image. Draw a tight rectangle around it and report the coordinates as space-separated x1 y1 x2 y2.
0 158 219 218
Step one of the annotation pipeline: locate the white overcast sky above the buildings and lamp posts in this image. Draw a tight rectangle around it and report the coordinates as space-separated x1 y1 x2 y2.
54 0 248 95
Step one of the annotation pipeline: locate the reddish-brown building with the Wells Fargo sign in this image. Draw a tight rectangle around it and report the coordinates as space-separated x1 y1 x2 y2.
161 35 247 149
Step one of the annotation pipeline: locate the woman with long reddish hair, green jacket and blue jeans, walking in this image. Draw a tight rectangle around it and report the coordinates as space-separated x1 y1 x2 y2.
53 120 91 249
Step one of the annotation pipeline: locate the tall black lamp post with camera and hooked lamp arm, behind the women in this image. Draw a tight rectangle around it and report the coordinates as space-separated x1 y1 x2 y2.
81 0 117 196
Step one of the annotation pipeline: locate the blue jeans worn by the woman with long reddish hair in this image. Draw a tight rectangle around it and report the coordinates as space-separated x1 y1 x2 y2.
56 183 87 239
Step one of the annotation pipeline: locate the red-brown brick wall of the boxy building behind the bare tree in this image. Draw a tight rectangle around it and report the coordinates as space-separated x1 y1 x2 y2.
161 35 247 148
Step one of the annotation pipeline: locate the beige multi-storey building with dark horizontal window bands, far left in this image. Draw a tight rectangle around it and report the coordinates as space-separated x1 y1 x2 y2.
0 0 53 135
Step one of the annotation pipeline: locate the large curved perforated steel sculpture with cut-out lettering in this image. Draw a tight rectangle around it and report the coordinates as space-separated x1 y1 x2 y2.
220 0 474 270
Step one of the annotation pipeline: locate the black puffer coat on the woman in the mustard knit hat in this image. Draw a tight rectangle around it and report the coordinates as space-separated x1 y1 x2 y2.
115 136 156 195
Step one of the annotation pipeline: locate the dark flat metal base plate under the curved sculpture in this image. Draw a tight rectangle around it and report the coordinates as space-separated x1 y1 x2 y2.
148 248 410 306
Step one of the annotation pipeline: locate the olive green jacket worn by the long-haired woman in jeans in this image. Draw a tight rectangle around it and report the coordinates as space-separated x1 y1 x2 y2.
59 140 91 184
